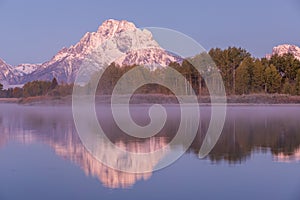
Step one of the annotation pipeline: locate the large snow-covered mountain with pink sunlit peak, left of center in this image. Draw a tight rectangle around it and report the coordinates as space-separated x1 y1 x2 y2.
0 19 181 85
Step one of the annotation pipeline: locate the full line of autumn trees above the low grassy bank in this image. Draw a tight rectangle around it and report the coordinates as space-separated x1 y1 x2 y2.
0 47 300 98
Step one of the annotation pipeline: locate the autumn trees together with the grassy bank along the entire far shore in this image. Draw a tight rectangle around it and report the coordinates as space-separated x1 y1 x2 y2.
0 47 300 105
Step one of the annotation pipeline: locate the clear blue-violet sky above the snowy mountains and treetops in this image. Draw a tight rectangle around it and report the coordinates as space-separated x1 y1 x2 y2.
0 0 300 65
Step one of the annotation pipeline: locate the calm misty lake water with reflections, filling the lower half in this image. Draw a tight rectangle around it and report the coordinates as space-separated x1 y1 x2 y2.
0 104 300 200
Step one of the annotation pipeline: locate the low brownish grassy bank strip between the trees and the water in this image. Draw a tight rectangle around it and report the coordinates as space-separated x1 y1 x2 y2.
0 94 300 106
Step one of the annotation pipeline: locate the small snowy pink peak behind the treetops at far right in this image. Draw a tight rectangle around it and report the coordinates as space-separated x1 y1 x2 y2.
266 44 300 60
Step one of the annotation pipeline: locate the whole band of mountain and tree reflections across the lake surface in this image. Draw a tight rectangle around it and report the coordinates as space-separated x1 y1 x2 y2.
0 105 300 188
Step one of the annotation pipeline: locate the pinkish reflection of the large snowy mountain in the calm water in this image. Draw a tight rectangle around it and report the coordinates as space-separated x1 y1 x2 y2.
0 106 170 188
